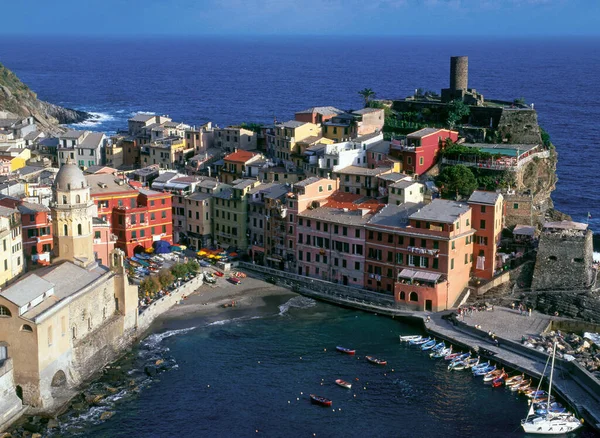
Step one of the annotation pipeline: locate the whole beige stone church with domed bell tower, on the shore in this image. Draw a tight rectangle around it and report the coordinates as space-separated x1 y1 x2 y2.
0 162 138 414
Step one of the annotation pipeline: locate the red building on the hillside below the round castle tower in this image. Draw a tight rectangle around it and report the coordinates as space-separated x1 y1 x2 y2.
391 128 458 175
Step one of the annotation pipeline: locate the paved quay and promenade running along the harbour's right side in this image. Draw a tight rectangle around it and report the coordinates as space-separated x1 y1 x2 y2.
243 263 600 431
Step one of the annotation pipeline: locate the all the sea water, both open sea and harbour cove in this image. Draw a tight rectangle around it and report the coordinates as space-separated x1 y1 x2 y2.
0 35 600 437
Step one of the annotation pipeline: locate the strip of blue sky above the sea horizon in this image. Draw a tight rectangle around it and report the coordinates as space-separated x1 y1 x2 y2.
0 0 600 36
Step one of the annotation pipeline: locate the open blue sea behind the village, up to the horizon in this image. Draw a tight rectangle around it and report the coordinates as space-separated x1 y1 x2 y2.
0 37 600 232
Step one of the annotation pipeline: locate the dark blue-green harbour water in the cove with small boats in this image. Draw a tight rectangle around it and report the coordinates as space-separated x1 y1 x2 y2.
50 297 584 438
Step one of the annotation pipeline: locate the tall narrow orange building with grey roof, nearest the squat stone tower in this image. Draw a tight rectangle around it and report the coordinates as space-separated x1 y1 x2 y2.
468 190 505 280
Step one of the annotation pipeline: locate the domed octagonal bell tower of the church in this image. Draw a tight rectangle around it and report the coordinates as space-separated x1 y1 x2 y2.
51 160 95 267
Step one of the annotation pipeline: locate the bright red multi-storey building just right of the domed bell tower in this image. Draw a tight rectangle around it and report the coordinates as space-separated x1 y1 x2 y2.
86 174 173 257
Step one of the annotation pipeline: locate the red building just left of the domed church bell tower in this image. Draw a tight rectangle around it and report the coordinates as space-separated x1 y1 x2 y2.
0 196 52 263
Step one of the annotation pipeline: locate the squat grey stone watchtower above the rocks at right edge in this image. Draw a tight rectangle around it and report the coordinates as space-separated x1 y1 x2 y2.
531 221 594 293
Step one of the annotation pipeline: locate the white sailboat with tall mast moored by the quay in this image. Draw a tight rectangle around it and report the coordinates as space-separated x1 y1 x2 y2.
521 341 582 435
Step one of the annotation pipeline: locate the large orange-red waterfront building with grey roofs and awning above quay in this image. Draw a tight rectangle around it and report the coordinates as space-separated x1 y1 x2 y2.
365 199 475 311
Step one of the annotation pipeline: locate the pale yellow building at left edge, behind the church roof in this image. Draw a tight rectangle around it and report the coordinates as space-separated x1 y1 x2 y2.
0 206 25 287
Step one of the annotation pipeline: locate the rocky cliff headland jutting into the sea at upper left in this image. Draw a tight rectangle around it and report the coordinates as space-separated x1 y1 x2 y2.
0 64 91 132
